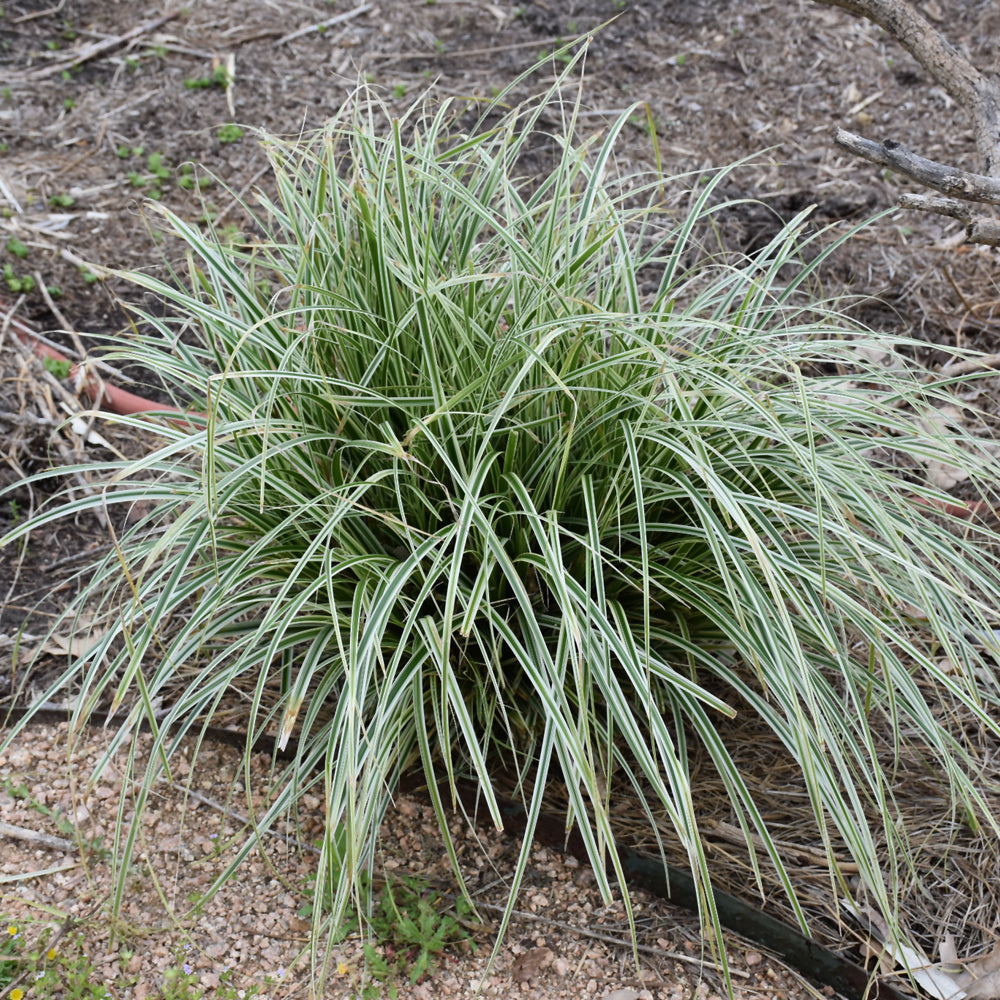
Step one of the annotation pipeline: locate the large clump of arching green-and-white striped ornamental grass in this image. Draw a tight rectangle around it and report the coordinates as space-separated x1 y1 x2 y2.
10 70 1000 988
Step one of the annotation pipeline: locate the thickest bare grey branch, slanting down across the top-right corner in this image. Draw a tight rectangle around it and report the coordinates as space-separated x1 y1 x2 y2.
819 0 1000 178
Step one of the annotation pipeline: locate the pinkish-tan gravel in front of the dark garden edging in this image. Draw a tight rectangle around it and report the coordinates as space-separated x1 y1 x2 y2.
0 724 834 1000
